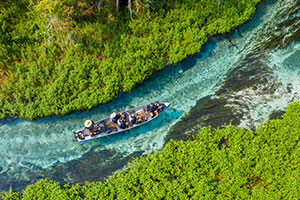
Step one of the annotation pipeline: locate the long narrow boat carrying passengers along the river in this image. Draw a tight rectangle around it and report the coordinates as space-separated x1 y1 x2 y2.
73 103 170 143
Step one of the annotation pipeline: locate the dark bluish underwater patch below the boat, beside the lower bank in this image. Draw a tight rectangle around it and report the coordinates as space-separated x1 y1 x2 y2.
47 147 142 187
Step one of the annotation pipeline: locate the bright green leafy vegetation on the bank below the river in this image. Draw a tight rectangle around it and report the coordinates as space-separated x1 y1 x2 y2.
2 102 300 199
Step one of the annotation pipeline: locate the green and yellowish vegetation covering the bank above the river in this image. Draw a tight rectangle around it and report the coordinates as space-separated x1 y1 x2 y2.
0 0 260 119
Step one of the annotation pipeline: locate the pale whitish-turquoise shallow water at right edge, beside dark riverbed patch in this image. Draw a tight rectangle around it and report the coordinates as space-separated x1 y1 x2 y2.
228 42 300 128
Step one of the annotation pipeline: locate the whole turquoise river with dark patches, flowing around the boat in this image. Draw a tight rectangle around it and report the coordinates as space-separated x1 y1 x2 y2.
0 0 300 191
